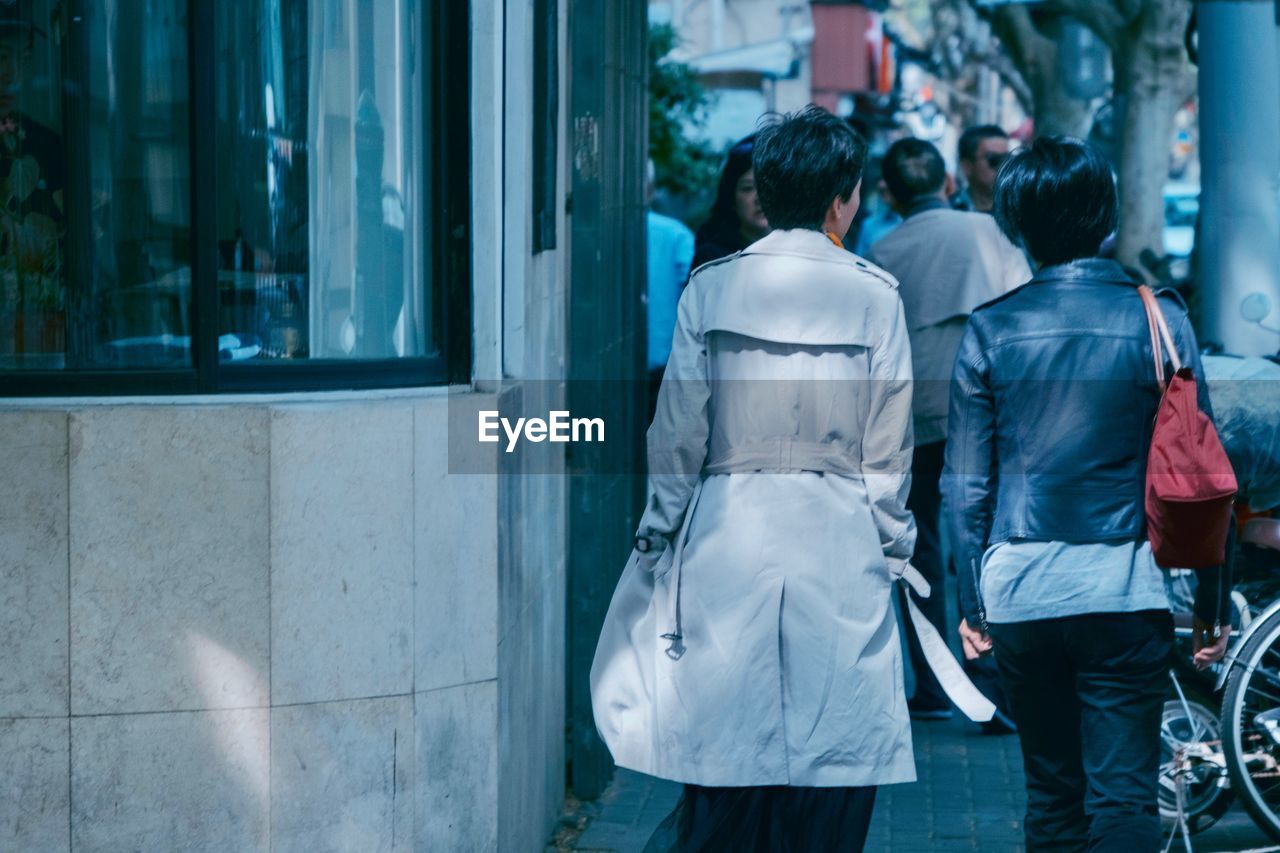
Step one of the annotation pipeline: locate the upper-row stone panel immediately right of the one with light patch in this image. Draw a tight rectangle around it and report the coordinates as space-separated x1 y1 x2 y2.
271 401 413 704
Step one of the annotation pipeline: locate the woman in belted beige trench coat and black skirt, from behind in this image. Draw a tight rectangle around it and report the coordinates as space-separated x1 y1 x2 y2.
591 108 915 850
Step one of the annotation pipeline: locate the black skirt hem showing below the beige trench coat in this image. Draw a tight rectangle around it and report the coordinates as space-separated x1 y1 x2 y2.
644 785 876 853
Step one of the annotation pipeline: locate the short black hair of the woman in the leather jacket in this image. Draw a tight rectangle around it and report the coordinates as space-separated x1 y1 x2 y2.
993 136 1119 266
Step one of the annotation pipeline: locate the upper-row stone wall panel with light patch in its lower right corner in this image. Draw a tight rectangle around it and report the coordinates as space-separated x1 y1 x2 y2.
70 406 270 715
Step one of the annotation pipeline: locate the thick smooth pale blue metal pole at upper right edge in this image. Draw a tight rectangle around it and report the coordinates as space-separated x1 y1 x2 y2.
1196 0 1280 355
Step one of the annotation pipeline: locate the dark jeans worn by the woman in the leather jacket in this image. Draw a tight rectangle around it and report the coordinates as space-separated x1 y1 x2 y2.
991 611 1174 853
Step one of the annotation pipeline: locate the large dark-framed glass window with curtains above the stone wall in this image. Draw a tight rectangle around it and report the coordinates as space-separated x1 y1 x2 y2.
0 0 460 394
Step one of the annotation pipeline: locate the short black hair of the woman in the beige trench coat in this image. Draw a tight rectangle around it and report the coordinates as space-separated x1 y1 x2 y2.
753 105 867 231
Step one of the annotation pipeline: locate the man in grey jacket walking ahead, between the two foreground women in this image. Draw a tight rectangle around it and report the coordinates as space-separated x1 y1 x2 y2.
870 138 1032 731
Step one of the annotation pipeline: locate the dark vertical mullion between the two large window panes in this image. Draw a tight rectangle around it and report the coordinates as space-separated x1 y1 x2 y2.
187 0 219 393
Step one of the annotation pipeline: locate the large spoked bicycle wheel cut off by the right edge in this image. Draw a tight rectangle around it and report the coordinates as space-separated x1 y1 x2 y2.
1222 613 1280 841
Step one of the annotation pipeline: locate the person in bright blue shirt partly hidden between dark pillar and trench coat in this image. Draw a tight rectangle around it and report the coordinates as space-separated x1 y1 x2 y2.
645 160 694 416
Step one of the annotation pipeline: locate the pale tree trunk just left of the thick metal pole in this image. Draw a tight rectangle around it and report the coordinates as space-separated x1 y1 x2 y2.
1114 0 1192 266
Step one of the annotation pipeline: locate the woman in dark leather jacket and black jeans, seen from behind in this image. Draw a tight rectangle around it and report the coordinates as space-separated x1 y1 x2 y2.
943 137 1230 853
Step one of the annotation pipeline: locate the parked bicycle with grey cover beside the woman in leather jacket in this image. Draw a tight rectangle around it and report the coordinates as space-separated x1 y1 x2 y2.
1160 356 1280 850
